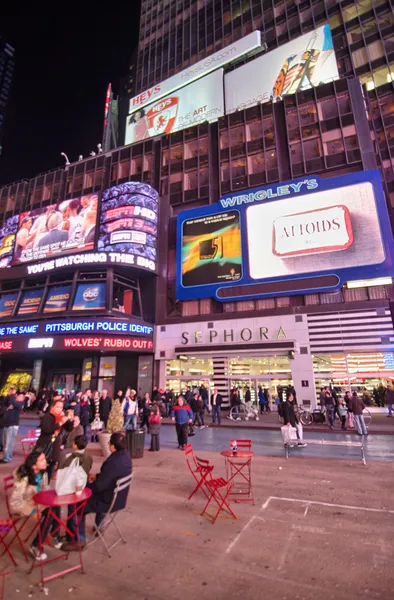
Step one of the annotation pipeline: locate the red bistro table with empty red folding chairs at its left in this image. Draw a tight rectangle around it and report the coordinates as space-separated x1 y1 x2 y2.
220 450 255 504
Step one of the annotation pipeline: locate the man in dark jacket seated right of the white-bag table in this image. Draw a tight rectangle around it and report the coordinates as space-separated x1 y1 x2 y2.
62 432 132 552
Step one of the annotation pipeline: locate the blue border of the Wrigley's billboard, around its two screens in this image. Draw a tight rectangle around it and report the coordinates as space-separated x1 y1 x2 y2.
176 169 394 302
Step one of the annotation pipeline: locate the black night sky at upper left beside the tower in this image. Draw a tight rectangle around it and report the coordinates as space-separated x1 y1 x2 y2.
0 5 140 185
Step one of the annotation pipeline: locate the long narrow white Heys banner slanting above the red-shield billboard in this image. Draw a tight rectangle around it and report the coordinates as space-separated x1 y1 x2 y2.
129 31 261 113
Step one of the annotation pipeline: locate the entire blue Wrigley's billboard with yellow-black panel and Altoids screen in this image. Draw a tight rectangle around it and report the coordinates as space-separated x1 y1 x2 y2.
177 171 392 301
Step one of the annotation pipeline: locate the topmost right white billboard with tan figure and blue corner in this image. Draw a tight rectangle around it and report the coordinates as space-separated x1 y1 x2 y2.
224 25 339 114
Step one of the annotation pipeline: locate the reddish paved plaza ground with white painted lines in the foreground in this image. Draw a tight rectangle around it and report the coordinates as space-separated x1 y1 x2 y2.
1 428 394 600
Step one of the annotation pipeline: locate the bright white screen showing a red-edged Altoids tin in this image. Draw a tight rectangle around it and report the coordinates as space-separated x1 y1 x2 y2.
246 183 385 279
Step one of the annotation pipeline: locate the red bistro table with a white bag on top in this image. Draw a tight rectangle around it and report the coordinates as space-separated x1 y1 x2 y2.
30 488 92 585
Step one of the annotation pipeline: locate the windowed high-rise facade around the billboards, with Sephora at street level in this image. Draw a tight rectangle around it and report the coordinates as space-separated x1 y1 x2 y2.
131 0 394 404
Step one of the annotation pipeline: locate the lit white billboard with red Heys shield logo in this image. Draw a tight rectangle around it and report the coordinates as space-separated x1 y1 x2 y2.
125 69 224 145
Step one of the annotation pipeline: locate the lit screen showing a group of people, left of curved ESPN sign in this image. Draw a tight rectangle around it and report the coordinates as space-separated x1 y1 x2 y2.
12 194 98 265
